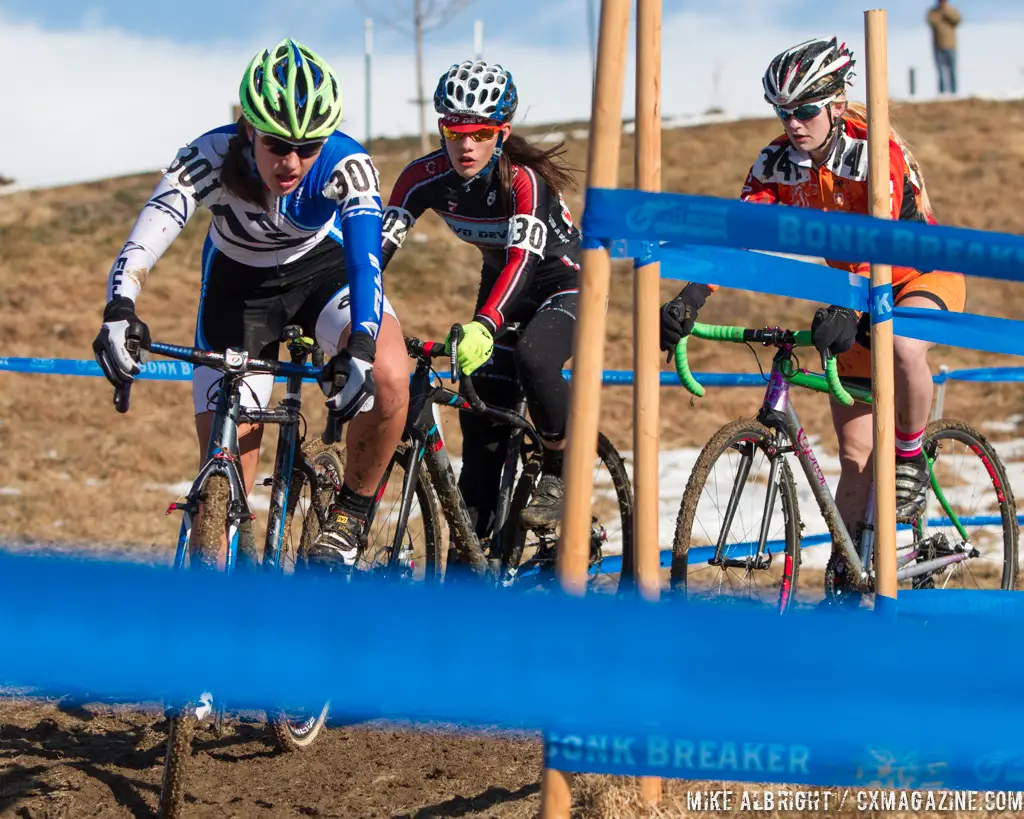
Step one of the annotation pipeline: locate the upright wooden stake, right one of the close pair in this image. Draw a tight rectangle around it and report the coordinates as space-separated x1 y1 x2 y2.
633 0 662 806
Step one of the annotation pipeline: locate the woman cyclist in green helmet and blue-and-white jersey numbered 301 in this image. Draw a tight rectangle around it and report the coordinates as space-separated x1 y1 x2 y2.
93 40 409 565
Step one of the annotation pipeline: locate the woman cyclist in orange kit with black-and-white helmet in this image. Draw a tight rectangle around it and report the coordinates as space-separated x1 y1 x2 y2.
662 38 967 588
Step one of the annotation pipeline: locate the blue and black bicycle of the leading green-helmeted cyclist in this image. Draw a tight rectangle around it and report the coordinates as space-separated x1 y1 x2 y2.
114 326 344 819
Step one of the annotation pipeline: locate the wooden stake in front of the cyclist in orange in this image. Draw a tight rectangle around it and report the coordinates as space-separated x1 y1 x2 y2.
864 9 896 601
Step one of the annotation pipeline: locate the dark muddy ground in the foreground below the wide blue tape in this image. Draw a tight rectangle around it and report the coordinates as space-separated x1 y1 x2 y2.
0 699 1011 819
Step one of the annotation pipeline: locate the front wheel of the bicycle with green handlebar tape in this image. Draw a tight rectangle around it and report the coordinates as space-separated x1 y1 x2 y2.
671 419 800 612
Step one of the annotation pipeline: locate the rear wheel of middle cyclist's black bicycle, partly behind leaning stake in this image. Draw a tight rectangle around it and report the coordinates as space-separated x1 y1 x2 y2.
502 433 636 594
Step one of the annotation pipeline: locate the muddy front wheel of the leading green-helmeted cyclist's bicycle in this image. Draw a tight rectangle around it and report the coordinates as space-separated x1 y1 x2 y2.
158 474 230 819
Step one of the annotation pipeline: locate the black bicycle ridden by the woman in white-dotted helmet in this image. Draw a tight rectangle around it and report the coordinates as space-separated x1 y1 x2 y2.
352 325 635 592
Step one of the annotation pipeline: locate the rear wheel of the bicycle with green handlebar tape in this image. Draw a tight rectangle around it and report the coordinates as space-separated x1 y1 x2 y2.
897 420 1019 590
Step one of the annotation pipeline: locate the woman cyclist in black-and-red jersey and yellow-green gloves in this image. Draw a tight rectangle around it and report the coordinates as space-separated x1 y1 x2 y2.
383 61 580 536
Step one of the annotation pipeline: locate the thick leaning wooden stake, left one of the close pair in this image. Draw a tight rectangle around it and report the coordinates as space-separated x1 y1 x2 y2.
541 0 630 819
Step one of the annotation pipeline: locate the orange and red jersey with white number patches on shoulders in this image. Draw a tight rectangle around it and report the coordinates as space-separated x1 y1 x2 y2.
740 113 935 287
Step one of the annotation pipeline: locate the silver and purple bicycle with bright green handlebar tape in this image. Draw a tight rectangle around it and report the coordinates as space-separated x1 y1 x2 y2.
670 322 1019 612
